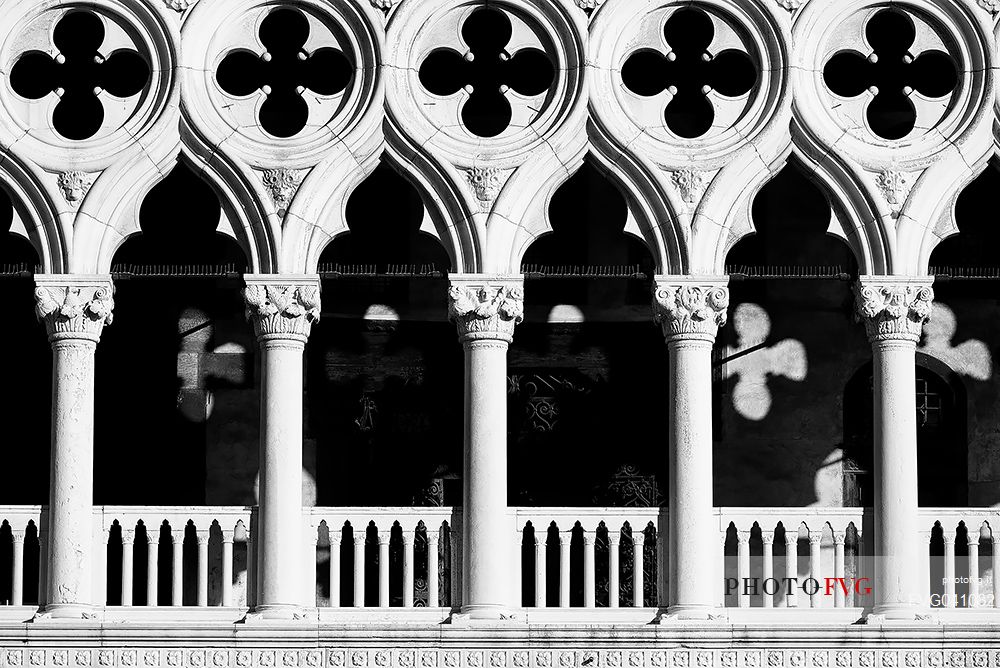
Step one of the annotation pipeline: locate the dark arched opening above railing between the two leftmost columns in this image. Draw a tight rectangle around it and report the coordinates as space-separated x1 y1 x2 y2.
95 164 257 504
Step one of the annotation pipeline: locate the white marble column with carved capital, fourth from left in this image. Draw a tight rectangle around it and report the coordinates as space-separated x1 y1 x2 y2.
653 276 729 619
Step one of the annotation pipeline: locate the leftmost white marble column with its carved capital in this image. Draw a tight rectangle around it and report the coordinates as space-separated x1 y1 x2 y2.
35 274 114 618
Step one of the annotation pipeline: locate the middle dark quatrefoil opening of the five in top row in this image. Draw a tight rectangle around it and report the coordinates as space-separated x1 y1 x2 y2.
419 7 555 137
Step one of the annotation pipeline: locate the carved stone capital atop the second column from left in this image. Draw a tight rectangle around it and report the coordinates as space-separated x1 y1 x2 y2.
243 274 320 343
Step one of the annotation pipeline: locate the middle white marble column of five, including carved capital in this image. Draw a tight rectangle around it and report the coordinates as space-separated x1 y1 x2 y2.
448 274 524 620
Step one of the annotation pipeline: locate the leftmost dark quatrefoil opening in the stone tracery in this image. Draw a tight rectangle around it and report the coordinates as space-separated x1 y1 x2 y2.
10 11 150 140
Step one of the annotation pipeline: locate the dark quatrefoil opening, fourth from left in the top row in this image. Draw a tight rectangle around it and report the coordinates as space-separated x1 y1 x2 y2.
622 7 757 139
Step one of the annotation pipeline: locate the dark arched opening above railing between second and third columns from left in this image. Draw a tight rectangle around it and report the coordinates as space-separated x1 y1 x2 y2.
306 163 464 505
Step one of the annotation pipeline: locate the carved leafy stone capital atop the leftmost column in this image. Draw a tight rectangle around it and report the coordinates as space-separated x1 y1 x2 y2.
35 274 115 343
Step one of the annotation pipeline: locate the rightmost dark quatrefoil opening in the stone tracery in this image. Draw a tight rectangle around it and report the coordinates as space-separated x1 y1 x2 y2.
823 9 958 140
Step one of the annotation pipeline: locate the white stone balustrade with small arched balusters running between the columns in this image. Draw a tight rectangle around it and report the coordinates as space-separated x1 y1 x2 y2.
0 506 1000 619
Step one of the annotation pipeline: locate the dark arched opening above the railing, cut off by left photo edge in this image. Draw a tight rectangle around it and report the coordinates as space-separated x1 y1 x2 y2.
0 190 52 500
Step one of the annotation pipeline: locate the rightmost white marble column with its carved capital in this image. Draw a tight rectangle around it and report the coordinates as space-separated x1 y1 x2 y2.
855 276 934 622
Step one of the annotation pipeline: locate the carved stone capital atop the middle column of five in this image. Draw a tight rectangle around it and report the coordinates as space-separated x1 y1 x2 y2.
448 274 524 343
